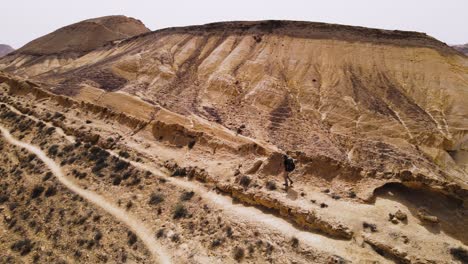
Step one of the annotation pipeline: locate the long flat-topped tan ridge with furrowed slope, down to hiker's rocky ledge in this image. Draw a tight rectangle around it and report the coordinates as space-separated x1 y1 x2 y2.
0 17 468 262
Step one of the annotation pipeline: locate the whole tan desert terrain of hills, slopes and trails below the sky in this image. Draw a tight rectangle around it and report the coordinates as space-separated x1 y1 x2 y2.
0 16 468 263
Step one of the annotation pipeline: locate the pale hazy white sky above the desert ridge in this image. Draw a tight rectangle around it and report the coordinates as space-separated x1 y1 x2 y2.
0 0 468 48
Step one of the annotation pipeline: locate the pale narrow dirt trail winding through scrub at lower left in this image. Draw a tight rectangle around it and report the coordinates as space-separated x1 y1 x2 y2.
0 125 171 264
